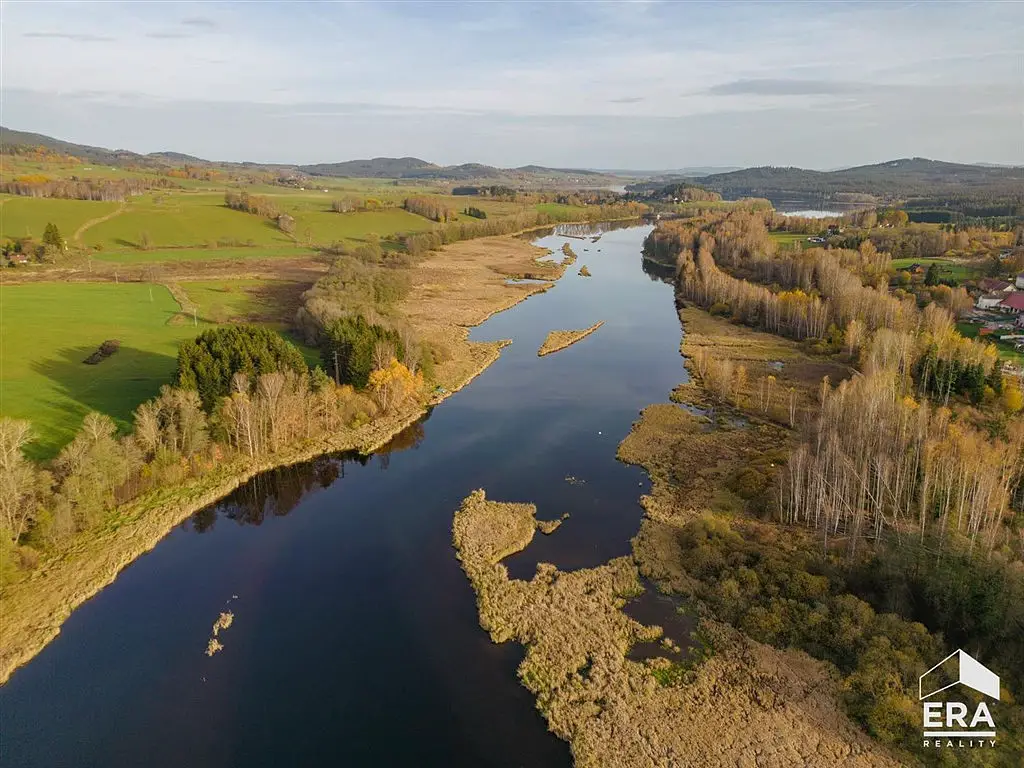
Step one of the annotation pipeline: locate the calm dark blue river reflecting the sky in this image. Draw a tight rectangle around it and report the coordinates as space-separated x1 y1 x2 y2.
0 227 685 768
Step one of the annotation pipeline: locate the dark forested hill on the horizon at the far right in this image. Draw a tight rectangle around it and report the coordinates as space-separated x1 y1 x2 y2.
700 158 1024 200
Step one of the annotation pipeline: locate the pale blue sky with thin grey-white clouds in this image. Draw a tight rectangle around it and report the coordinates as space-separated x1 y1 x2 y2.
0 0 1024 169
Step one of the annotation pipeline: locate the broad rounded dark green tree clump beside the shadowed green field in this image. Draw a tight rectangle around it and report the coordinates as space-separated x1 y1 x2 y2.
174 326 307 411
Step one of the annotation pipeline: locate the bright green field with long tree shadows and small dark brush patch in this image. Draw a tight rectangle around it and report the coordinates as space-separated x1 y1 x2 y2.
0 281 316 459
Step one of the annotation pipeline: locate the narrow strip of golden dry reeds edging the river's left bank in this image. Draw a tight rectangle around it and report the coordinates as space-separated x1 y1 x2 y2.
0 236 564 685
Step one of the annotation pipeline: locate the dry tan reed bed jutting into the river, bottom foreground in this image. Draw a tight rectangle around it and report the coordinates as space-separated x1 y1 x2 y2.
453 490 896 768
